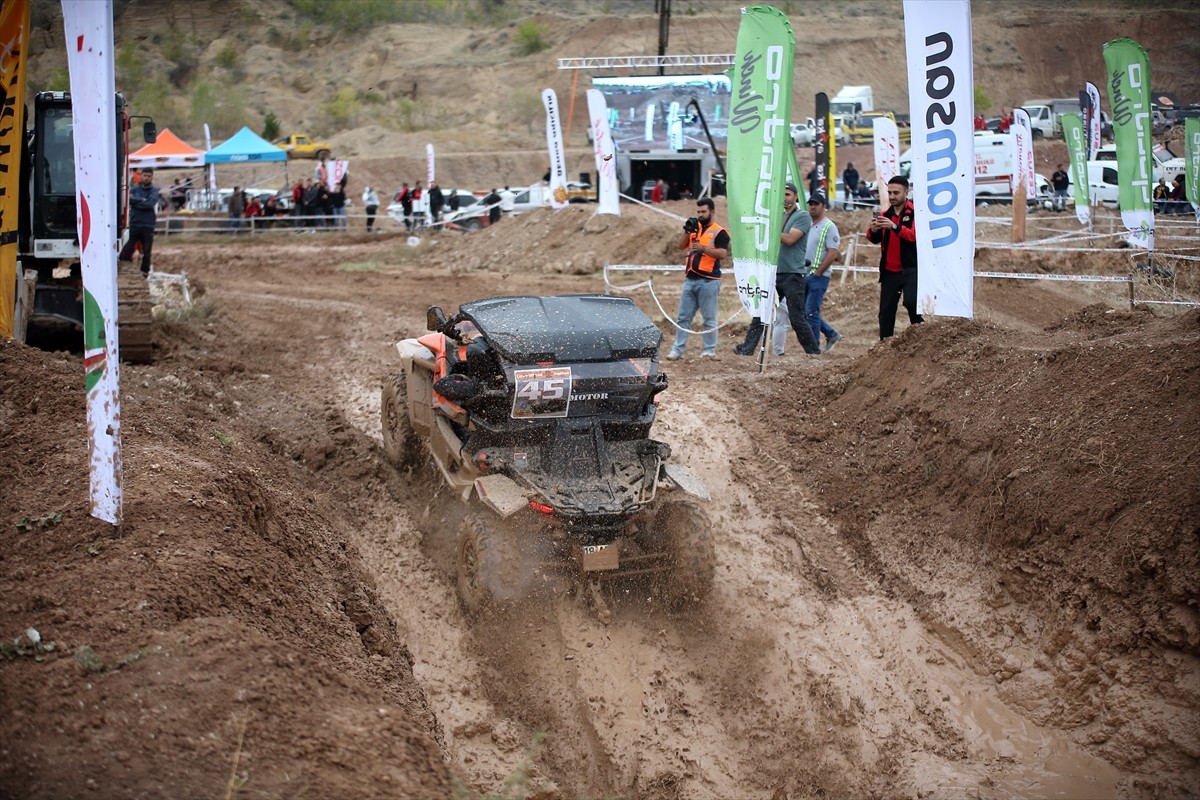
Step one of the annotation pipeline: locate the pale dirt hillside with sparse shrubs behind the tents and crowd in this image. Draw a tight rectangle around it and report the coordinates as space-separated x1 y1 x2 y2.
23 0 1200 191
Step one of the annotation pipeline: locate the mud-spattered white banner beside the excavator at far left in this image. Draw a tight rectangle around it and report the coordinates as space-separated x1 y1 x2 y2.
62 0 124 525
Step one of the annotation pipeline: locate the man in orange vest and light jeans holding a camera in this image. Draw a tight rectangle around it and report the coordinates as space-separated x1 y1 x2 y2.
667 197 730 361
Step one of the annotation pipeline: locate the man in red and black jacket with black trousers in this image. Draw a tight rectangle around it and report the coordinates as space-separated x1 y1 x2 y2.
866 175 925 339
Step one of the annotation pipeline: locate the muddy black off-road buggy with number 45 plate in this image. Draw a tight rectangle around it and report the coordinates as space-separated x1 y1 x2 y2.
382 295 714 612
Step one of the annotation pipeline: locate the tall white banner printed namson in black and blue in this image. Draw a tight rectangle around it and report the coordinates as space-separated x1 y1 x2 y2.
904 0 974 318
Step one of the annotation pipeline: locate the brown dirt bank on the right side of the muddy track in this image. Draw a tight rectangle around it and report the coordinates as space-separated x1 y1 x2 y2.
748 305 1200 788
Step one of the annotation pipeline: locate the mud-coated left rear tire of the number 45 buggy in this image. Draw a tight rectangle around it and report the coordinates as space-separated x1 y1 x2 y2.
456 513 538 614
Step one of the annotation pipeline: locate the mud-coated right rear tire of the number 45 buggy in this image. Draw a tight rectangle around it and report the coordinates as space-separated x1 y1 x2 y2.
647 500 716 608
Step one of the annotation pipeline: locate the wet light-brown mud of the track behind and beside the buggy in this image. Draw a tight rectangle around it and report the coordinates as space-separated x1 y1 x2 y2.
331 367 1118 799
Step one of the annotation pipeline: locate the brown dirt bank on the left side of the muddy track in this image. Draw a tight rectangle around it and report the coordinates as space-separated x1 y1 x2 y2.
0 342 451 799
